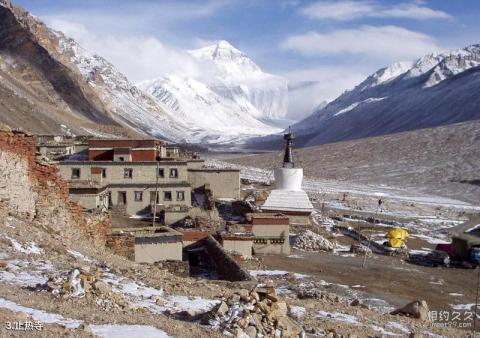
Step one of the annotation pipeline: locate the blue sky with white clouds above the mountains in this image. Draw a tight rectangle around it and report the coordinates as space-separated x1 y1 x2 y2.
14 0 480 119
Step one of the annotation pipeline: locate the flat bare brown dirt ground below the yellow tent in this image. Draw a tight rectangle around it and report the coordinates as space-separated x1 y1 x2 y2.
263 251 477 310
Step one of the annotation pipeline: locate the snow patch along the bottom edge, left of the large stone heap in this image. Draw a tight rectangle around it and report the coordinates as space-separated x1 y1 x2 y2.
89 324 170 338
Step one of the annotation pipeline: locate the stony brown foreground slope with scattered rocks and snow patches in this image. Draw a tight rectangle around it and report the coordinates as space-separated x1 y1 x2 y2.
0 207 470 337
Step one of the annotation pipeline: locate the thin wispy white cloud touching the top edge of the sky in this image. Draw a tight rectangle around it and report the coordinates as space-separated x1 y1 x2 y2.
300 1 451 20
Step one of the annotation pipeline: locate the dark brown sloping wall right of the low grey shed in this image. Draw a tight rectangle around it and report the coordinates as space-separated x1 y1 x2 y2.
204 236 252 281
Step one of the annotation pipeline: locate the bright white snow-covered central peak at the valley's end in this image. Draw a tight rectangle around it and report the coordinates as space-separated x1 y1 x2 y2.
139 41 288 142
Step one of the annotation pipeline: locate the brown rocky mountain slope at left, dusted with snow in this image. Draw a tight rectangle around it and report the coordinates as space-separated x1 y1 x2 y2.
0 0 225 141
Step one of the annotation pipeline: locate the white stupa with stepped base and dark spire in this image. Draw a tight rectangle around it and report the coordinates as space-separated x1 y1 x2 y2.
261 132 313 216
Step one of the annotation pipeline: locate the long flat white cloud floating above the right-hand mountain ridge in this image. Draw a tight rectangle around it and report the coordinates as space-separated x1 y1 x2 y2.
281 26 441 62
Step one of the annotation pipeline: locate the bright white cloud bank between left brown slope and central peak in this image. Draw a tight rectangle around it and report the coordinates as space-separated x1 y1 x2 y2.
48 19 205 82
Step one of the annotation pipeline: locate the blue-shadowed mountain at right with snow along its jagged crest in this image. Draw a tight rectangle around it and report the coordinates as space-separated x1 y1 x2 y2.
293 45 480 145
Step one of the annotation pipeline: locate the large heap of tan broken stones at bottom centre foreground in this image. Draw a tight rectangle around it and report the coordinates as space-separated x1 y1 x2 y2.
202 287 303 338
